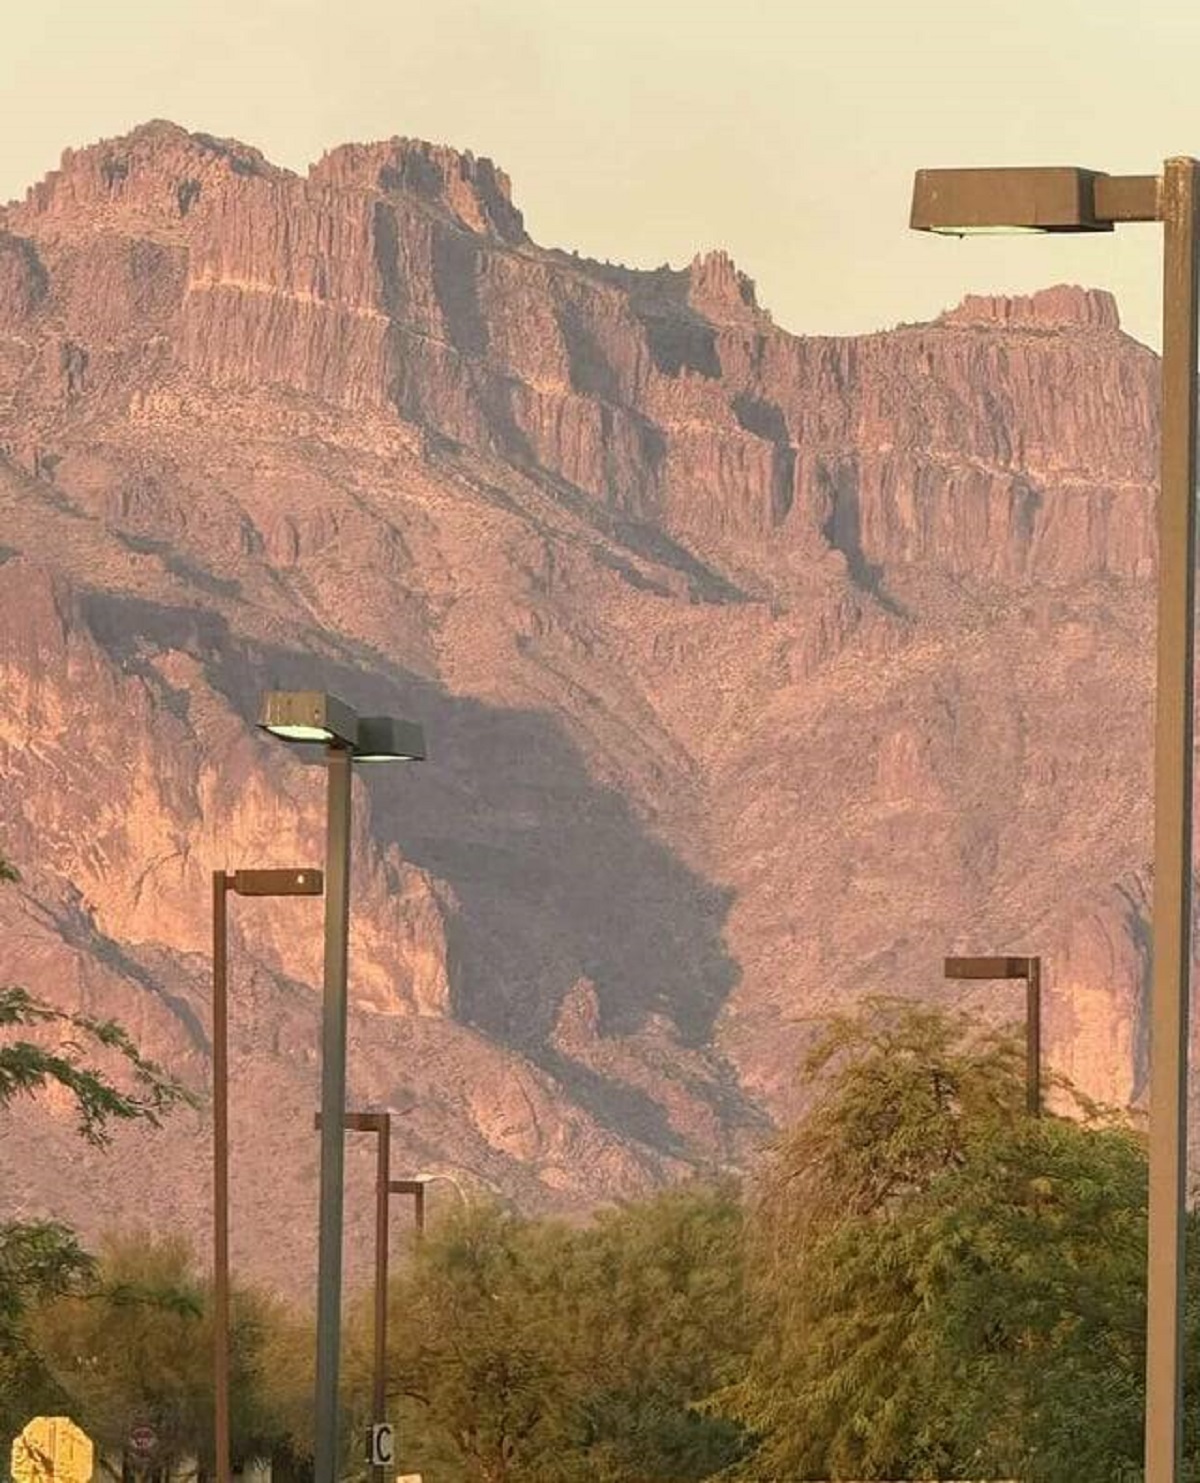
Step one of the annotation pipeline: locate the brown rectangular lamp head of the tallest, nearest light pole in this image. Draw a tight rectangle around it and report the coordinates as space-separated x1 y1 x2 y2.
909 166 1112 236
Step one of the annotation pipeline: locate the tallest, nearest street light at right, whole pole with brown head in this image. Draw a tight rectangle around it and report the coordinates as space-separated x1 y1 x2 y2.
911 157 1200 1483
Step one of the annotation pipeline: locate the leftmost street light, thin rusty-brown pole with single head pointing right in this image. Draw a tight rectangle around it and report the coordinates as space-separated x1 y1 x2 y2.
212 871 323 1483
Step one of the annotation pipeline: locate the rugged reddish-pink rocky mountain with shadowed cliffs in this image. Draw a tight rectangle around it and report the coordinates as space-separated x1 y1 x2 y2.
0 123 1157 1283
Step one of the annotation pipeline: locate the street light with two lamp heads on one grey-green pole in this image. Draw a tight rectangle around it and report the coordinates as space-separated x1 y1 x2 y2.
258 690 426 1483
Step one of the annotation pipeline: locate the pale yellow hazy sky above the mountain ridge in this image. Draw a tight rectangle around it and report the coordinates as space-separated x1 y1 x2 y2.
0 0 1200 343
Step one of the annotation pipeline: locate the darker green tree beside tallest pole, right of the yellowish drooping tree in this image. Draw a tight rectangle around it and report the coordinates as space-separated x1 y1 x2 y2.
920 1118 1147 1483
